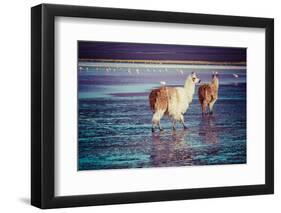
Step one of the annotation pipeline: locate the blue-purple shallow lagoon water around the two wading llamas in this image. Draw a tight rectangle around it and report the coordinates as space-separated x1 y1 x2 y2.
78 68 246 170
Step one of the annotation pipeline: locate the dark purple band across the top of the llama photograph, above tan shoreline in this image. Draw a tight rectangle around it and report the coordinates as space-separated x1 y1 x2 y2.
78 41 246 62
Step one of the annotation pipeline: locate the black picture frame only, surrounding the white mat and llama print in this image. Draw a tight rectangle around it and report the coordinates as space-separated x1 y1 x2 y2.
31 4 274 209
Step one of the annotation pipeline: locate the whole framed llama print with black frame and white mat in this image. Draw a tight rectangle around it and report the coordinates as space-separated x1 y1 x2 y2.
31 4 274 208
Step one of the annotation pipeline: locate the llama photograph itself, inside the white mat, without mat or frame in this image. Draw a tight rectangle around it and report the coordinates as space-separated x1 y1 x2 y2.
77 40 247 171
